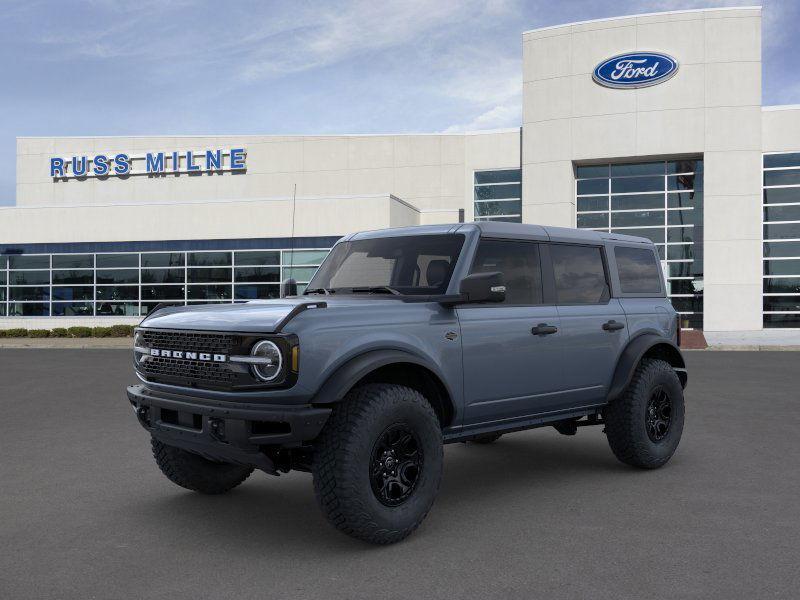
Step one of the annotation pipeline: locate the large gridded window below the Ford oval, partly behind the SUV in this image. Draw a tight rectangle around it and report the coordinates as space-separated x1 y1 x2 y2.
575 159 703 329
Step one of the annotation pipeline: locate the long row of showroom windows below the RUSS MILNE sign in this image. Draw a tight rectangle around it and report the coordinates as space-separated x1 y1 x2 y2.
0 248 329 317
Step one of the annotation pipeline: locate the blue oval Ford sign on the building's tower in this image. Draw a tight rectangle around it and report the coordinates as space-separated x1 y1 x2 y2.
592 52 678 88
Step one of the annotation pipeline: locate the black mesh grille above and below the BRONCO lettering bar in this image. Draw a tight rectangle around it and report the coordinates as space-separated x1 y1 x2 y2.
139 329 243 388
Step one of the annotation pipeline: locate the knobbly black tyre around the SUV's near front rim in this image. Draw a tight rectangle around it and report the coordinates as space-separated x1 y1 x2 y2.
312 384 443 544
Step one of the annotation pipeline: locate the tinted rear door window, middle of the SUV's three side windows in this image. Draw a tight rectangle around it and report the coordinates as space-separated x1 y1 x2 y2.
550 244 611 304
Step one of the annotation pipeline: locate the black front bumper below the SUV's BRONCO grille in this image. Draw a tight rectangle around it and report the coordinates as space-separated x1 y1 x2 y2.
128 385 331 473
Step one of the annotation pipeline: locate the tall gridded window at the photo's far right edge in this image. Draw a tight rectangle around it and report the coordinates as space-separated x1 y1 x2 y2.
762 152 800 329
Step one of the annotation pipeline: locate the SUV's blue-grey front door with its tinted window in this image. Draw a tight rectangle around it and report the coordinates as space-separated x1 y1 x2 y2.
457 239 563 428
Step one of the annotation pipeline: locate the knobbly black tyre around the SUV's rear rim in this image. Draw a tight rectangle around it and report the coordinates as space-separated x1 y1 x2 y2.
603 358 685 469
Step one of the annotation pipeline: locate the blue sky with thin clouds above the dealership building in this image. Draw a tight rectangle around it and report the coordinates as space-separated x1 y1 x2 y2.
0 0 800 205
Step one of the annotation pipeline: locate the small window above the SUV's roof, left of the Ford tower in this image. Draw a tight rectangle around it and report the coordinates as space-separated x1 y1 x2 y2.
474 169 522 223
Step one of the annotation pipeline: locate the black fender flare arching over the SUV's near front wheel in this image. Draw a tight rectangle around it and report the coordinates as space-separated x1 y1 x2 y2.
311 349 452 404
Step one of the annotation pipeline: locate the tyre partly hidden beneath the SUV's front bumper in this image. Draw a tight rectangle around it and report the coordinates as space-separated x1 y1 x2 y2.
150 438 253 494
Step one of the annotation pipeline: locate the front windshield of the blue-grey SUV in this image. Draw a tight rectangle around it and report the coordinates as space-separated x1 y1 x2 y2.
306 234 464 295
